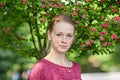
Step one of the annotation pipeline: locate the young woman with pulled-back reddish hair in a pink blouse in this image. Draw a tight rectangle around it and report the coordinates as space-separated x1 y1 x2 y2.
28 14 81 80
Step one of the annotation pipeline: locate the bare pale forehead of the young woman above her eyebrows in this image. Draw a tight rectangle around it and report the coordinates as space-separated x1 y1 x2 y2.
53 22 74 33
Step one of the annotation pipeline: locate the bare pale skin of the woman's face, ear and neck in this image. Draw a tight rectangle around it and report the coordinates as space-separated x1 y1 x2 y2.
45 22 74 67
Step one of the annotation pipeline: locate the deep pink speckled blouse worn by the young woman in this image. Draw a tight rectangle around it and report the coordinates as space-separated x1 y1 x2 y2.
28 59 81 80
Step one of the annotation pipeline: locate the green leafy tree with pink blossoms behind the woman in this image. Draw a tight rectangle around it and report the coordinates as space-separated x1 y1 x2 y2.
0 0 120 59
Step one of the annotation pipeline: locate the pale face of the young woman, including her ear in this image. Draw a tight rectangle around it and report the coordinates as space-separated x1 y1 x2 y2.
48 22 74 53
